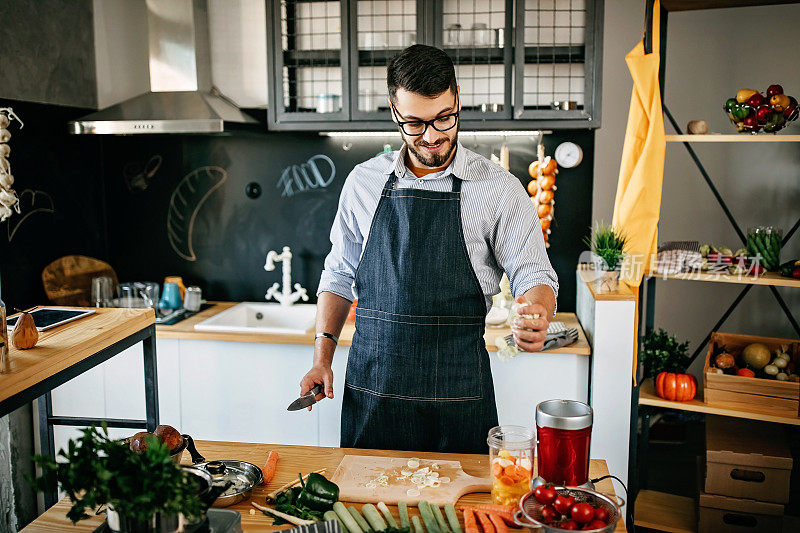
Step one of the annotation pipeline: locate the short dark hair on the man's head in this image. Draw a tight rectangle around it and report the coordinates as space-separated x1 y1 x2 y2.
386 44 457 102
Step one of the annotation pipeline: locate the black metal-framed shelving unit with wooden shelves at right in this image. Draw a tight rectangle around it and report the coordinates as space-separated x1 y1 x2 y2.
626 0 800 531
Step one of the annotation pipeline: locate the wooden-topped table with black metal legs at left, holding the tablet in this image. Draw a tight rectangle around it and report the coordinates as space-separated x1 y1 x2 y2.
0 309 158 507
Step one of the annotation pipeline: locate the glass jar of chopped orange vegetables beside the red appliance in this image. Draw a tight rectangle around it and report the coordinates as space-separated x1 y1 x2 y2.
486 426 535 505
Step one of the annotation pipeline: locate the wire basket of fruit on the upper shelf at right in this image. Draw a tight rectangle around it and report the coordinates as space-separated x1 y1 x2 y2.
724 85 798 133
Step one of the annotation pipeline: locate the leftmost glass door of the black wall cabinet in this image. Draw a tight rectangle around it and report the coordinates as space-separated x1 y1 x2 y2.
272 0 350 122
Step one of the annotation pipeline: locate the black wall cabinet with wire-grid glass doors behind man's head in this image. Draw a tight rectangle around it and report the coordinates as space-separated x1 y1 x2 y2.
267 0 603 131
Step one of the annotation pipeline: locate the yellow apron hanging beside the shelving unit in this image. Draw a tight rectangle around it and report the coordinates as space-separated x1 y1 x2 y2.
612 0 666 382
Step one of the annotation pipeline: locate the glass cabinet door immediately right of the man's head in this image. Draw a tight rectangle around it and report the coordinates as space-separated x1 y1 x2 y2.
434 0 514 120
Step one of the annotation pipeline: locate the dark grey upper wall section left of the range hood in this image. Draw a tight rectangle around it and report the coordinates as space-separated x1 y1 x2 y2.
0 0 97 107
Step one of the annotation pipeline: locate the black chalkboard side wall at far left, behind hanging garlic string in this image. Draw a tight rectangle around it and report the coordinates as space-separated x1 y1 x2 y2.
0 99 107 310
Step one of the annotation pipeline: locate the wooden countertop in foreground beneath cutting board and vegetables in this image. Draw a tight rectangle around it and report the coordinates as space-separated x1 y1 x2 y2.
23 441 625 533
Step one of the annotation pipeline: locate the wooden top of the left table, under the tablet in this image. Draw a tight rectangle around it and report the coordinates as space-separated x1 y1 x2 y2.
0 309 155 408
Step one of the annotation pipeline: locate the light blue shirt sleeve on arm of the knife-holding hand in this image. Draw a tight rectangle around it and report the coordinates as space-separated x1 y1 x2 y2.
317 177 363 302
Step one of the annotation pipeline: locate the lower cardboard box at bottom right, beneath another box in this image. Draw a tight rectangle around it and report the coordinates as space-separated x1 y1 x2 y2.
697 493 783 533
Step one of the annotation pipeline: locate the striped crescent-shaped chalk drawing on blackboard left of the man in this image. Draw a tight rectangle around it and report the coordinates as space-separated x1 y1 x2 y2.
167 166 228 261
